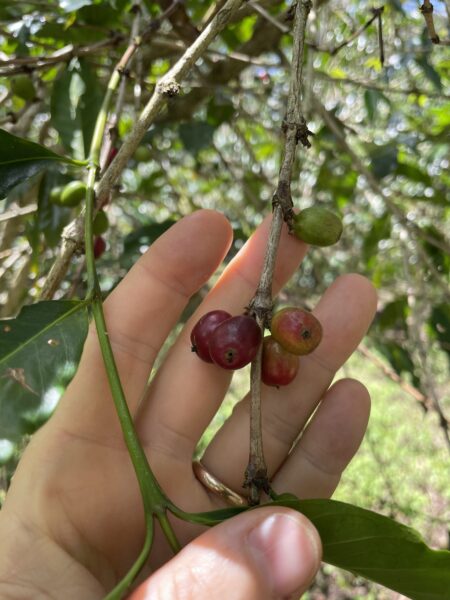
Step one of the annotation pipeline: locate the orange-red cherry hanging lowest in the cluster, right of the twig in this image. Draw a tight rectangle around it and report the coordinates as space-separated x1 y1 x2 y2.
261 335 299 387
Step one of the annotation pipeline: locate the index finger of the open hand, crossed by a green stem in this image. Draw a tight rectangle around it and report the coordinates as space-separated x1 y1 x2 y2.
57 210 232 437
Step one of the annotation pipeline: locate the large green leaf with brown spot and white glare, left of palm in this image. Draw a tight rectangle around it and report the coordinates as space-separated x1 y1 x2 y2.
0 301 88 441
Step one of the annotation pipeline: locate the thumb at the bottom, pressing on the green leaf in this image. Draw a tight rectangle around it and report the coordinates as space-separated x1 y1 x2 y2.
130 507 322 600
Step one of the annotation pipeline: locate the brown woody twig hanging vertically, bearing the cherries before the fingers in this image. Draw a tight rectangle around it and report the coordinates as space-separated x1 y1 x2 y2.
244 0 312 505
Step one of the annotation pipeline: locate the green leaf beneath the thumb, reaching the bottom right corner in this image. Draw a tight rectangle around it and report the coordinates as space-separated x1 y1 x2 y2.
185 493 450 600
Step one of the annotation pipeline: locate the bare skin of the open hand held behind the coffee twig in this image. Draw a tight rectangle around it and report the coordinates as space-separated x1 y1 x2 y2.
0 210 376 600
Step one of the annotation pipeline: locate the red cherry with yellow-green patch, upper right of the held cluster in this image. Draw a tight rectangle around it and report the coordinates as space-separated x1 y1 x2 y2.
270 306 322 355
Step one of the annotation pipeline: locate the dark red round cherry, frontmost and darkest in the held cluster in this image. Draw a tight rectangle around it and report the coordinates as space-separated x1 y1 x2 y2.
209 315 262 370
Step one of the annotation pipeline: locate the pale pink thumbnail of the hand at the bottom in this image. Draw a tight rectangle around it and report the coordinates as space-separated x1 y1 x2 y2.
247 513 321 597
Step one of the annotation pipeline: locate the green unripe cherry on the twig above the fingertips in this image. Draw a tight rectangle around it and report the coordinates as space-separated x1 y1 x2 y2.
292 206 342 246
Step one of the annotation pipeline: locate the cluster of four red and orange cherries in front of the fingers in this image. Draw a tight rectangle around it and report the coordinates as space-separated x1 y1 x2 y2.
191 307 322 387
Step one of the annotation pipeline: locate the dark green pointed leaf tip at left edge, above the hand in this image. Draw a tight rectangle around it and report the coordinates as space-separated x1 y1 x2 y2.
0 129 78 199
